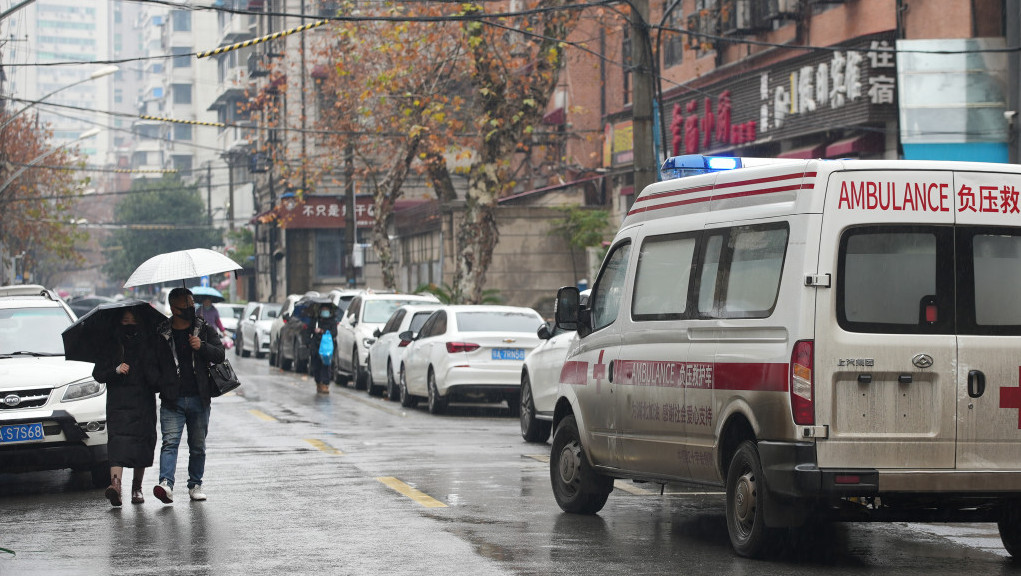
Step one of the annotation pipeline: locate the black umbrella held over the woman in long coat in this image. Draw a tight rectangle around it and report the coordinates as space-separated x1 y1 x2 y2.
60 300 166 364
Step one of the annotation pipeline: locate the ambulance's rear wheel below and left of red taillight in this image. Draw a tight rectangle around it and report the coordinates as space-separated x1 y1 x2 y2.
727 440 782 558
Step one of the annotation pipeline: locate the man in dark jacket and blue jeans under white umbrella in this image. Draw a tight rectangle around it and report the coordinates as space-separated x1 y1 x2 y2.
152 288 224 503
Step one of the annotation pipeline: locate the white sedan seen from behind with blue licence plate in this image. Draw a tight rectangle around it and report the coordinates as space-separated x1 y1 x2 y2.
399 305 543 416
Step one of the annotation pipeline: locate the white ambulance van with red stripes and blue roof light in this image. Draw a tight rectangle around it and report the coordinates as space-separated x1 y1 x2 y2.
550 156 1021 557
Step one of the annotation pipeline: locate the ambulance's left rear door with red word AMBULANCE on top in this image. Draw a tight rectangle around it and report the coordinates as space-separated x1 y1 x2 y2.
813 170 958 469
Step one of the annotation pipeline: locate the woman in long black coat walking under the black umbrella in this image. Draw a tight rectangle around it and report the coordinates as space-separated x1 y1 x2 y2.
92 308 159 506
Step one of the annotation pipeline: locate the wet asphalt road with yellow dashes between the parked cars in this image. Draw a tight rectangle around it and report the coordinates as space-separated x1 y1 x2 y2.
0 356 1021 576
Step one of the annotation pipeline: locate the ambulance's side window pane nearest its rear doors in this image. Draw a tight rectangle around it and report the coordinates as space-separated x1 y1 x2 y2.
697 223 788 318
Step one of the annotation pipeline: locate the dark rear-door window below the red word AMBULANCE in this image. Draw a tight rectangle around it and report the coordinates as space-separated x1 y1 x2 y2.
836 226 955 334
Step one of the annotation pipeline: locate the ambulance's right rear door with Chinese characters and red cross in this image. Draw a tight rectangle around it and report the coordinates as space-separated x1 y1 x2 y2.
954 172 1021 469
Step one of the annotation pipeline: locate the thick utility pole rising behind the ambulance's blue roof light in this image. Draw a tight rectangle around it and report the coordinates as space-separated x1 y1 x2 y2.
631 0 659 199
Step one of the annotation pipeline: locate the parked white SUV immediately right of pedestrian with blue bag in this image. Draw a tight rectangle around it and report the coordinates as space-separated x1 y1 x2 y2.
333 291 439 390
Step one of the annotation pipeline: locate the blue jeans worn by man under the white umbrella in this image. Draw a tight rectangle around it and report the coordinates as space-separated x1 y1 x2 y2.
159 396 209 489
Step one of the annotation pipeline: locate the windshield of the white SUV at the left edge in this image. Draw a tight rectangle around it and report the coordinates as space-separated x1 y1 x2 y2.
0 307 71 355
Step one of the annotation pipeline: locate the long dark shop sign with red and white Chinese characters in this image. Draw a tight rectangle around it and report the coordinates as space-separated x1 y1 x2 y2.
666 33 896 155
